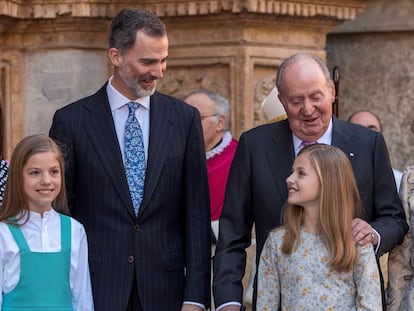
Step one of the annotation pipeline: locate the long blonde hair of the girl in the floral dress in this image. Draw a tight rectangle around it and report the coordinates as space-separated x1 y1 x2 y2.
281 144 362 272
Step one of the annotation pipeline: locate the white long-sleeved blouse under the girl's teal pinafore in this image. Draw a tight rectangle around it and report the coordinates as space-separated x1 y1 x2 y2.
0 209 94 311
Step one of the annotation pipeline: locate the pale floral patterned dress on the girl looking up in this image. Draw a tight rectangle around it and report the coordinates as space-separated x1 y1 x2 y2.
256 229 382 311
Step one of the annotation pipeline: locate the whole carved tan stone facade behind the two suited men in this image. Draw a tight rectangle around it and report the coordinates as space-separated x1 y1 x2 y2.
0 0 367 156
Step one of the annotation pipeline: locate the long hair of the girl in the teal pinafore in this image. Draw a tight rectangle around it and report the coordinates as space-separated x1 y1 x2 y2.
0 134 69 224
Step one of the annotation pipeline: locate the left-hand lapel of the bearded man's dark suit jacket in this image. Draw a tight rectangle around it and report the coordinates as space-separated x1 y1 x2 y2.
84 84 134 216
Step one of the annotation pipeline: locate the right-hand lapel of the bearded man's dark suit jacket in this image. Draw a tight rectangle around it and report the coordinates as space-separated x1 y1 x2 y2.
139 92 173 214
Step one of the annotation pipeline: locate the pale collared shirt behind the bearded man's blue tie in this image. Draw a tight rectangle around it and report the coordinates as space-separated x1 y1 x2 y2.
106 76 150 162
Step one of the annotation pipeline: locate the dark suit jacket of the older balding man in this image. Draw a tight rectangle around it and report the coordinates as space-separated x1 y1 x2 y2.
213 118 408 306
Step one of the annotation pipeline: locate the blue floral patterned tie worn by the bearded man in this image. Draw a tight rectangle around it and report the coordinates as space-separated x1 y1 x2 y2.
124 102 146 216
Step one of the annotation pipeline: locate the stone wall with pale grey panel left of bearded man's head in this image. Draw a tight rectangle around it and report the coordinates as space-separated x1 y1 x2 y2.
0 16 109 156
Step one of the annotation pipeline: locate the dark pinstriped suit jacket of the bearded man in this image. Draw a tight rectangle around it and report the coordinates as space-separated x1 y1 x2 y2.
50 85 211 311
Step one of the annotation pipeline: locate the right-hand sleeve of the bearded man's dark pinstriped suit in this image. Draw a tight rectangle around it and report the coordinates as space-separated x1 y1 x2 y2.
184 113 211 307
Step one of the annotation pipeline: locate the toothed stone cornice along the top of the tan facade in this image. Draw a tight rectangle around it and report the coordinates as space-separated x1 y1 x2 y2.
0 0 367 20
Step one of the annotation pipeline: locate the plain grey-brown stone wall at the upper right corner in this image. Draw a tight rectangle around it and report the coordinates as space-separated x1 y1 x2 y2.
327 0 414 170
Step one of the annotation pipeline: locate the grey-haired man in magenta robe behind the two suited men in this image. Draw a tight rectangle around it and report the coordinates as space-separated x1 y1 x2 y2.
184 89 237 244
